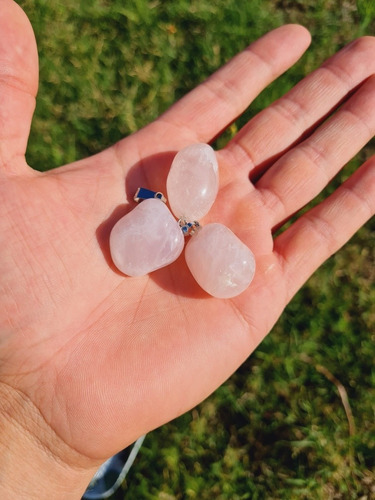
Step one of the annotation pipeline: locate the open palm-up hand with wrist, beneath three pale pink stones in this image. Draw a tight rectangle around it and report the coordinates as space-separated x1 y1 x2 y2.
0 0 375 499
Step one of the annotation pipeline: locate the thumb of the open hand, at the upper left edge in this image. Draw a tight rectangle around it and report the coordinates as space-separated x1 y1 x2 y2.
0 0 38 173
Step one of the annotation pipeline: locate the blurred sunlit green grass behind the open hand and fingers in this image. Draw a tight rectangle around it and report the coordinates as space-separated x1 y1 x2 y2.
19 0 375 500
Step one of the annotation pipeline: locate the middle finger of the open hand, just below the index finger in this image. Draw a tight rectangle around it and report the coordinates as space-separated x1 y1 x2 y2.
226 37 375 178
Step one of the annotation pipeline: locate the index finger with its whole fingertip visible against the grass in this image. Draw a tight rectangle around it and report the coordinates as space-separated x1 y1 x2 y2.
156 25 310 146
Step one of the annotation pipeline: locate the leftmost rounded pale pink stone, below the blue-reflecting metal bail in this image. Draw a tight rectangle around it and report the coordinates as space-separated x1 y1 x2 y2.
109 199 184 276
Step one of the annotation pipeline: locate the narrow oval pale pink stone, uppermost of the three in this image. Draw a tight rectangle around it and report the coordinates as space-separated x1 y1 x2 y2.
167 143 219 221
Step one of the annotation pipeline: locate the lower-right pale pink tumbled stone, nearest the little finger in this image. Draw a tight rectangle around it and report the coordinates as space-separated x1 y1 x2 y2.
185 223 255 299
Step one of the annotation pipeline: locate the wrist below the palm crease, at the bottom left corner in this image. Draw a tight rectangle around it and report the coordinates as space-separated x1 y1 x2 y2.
0 384 98 500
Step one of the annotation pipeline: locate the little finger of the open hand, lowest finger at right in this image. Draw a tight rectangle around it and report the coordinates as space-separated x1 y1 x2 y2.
274 157 375 300
